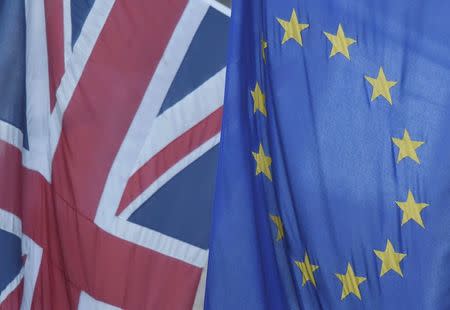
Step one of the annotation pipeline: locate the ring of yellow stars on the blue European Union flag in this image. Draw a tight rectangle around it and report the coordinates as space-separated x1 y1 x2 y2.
250 9 429 300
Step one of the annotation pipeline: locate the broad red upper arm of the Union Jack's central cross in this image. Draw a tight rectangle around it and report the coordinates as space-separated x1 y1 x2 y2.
52 0 187 219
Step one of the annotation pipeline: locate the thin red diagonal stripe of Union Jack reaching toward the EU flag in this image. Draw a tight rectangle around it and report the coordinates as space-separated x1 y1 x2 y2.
117 107 223 214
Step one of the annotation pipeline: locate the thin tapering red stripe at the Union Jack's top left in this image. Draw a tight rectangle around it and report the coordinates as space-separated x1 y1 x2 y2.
44 0 64 111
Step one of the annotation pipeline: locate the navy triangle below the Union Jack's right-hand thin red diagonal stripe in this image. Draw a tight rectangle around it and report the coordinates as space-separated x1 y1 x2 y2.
128 146 218 249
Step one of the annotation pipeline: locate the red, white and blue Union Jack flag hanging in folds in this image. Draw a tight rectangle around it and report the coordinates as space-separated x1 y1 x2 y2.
0 0 229 309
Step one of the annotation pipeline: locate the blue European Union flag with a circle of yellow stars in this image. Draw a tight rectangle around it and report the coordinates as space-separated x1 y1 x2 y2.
206 0 450 310
